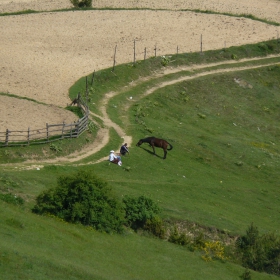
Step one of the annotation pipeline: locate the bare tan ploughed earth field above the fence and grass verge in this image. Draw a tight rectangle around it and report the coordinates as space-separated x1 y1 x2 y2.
0 0 280 132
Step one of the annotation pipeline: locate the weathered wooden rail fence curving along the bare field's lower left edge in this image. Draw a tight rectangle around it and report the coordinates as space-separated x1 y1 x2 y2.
0 93 89 147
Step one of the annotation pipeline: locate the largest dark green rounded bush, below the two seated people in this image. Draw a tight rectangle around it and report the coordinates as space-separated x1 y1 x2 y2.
32 171 124 232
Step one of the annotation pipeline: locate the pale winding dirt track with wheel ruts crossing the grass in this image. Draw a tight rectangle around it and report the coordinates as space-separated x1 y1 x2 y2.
1 54 280 170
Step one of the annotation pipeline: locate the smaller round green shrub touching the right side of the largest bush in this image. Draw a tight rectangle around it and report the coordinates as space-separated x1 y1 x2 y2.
123 196 161 230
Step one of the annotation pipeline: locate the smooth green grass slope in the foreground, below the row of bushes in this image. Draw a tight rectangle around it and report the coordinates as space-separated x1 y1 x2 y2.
0 201 276 280
